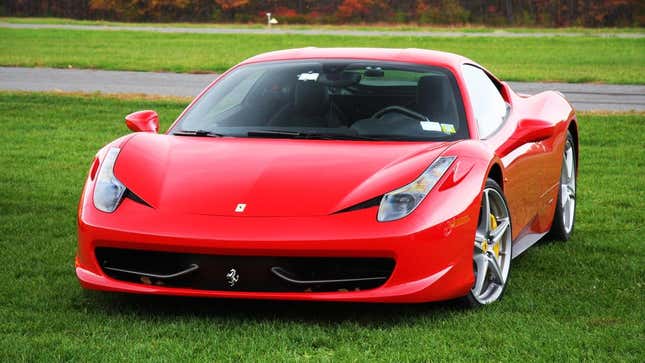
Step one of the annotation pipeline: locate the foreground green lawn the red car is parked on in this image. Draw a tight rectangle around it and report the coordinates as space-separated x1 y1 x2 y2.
0 93 645 362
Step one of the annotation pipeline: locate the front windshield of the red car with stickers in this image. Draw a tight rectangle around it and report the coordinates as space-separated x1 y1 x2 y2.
170 60 468 141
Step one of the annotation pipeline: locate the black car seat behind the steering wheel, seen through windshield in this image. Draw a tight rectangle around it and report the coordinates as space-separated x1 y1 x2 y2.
416 75 459 123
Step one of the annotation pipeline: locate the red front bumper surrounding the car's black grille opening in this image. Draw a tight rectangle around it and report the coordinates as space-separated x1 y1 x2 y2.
76 193 479 303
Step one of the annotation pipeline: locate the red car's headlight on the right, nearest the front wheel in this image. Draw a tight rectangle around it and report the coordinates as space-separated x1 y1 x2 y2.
378 156 455 222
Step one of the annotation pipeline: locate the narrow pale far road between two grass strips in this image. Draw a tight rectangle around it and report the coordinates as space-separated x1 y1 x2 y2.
0 22 645 38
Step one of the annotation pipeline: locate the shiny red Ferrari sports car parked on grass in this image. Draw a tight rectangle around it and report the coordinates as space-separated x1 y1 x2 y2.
76 48 578 306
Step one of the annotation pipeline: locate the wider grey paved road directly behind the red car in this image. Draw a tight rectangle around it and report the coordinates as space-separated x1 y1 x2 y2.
0 67 645 111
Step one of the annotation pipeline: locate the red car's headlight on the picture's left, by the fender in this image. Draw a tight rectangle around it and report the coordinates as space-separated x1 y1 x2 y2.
94 147 126 213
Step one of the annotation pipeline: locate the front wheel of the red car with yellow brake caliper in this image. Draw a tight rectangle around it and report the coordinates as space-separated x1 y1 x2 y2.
464 179 512 307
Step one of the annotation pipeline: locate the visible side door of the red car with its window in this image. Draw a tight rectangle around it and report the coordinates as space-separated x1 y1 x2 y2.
462 64 543 240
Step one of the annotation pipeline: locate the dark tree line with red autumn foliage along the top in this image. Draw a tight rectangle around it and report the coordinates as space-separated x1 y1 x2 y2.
0 0 645 27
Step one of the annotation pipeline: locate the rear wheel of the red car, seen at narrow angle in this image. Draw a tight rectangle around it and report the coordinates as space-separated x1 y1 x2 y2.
550 132 576 241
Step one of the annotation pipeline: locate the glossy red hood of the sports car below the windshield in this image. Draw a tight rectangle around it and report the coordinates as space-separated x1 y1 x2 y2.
115 133 448 216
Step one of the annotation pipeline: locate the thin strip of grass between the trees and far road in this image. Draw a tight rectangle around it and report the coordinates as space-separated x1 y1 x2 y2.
0 16 645 35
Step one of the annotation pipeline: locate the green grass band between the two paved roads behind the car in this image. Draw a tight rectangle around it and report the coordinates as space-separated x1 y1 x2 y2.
0 29 645 84
